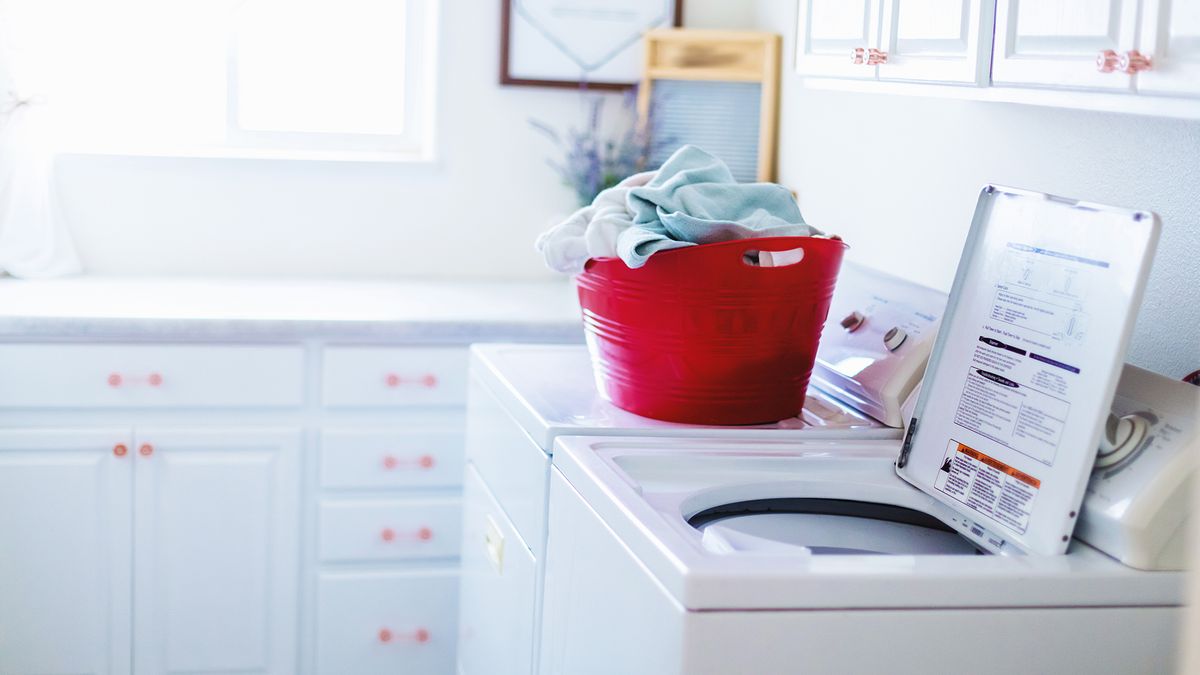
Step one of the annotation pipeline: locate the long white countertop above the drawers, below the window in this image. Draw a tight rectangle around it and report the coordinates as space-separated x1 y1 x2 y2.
0 276 582 344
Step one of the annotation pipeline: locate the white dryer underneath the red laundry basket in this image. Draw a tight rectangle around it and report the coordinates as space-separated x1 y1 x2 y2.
458 264 946 675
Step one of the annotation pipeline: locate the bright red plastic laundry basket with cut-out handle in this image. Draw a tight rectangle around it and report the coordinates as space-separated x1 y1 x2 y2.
577 237 846 425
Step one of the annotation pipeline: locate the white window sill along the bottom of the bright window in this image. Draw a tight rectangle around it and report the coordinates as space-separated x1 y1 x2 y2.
58 144 437 165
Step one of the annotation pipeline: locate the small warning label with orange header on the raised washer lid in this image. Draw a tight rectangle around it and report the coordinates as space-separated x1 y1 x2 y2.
934 441 1042 533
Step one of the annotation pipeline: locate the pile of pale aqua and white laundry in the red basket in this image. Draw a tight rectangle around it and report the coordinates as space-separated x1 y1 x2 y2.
536 145 822 274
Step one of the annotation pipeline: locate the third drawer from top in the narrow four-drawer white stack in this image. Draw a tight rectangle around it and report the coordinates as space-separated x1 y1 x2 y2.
320 497 462 562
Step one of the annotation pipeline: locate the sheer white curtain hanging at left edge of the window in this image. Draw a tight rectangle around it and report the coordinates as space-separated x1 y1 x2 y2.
0 2 82 279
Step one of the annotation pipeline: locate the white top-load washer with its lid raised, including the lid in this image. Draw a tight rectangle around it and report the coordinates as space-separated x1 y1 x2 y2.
540 187 1180 675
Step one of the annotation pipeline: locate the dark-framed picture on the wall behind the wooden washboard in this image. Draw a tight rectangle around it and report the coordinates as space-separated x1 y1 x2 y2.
500 0 683 89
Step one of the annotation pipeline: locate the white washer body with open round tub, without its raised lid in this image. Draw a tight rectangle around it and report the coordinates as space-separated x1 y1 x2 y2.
540 366 1200 675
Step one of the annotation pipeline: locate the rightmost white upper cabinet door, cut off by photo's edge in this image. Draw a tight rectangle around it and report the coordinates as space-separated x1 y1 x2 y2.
1138 0 1200 96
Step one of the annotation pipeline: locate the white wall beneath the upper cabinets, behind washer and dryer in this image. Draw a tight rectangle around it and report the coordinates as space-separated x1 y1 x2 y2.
757 0 1200 376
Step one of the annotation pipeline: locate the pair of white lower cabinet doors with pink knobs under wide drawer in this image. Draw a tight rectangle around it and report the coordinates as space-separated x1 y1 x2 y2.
0 429 299 675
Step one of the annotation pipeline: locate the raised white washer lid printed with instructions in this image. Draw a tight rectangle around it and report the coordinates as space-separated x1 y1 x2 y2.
896 186 1159 554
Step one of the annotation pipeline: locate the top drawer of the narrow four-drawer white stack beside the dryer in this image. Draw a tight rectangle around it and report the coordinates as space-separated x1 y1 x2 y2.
322 347 467 407
